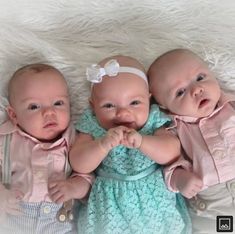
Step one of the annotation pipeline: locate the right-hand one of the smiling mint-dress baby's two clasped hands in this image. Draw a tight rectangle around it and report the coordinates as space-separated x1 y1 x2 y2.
121 129 142 148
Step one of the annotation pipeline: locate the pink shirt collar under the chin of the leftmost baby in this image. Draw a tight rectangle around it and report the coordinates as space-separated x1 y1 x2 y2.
0 120 75 149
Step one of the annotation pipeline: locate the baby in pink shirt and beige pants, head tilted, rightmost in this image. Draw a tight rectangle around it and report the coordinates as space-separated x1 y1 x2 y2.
148 49 235 234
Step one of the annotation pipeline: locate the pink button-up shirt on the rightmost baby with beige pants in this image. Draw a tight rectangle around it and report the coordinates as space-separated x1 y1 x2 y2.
165 94 235 191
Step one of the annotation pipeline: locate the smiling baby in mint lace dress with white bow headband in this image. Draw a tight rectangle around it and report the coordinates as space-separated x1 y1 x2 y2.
70 55 191 234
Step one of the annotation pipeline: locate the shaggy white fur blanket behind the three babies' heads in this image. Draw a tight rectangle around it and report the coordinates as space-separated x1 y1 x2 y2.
0 0 235 120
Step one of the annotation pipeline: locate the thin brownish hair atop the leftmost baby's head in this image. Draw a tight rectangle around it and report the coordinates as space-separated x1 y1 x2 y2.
8 63 63 100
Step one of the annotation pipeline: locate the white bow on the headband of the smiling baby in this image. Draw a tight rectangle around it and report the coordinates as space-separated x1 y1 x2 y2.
86 59 120 83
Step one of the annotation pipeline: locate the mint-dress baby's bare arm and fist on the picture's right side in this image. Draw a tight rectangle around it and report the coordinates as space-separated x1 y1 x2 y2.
125 128 180 164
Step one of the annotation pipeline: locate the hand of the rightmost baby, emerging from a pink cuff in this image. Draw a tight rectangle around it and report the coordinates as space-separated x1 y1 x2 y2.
172 169 203 198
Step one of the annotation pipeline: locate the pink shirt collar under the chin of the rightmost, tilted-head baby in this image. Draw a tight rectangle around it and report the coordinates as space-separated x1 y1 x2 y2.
170 92 235 124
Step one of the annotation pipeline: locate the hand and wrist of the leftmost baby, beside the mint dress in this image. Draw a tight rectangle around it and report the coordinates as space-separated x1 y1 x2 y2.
48 174 93 203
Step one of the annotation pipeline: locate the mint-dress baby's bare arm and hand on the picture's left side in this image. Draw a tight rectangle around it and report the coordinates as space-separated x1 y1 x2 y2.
69 126 126 173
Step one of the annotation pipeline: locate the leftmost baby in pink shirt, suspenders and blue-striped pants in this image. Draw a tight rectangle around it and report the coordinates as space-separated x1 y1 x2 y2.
0 64 91 234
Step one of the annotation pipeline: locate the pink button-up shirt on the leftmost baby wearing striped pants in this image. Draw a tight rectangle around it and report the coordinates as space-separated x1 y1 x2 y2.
0 121 92 202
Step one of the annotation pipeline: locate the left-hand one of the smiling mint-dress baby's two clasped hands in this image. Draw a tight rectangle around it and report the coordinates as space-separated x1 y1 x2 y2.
100 126 127 152
